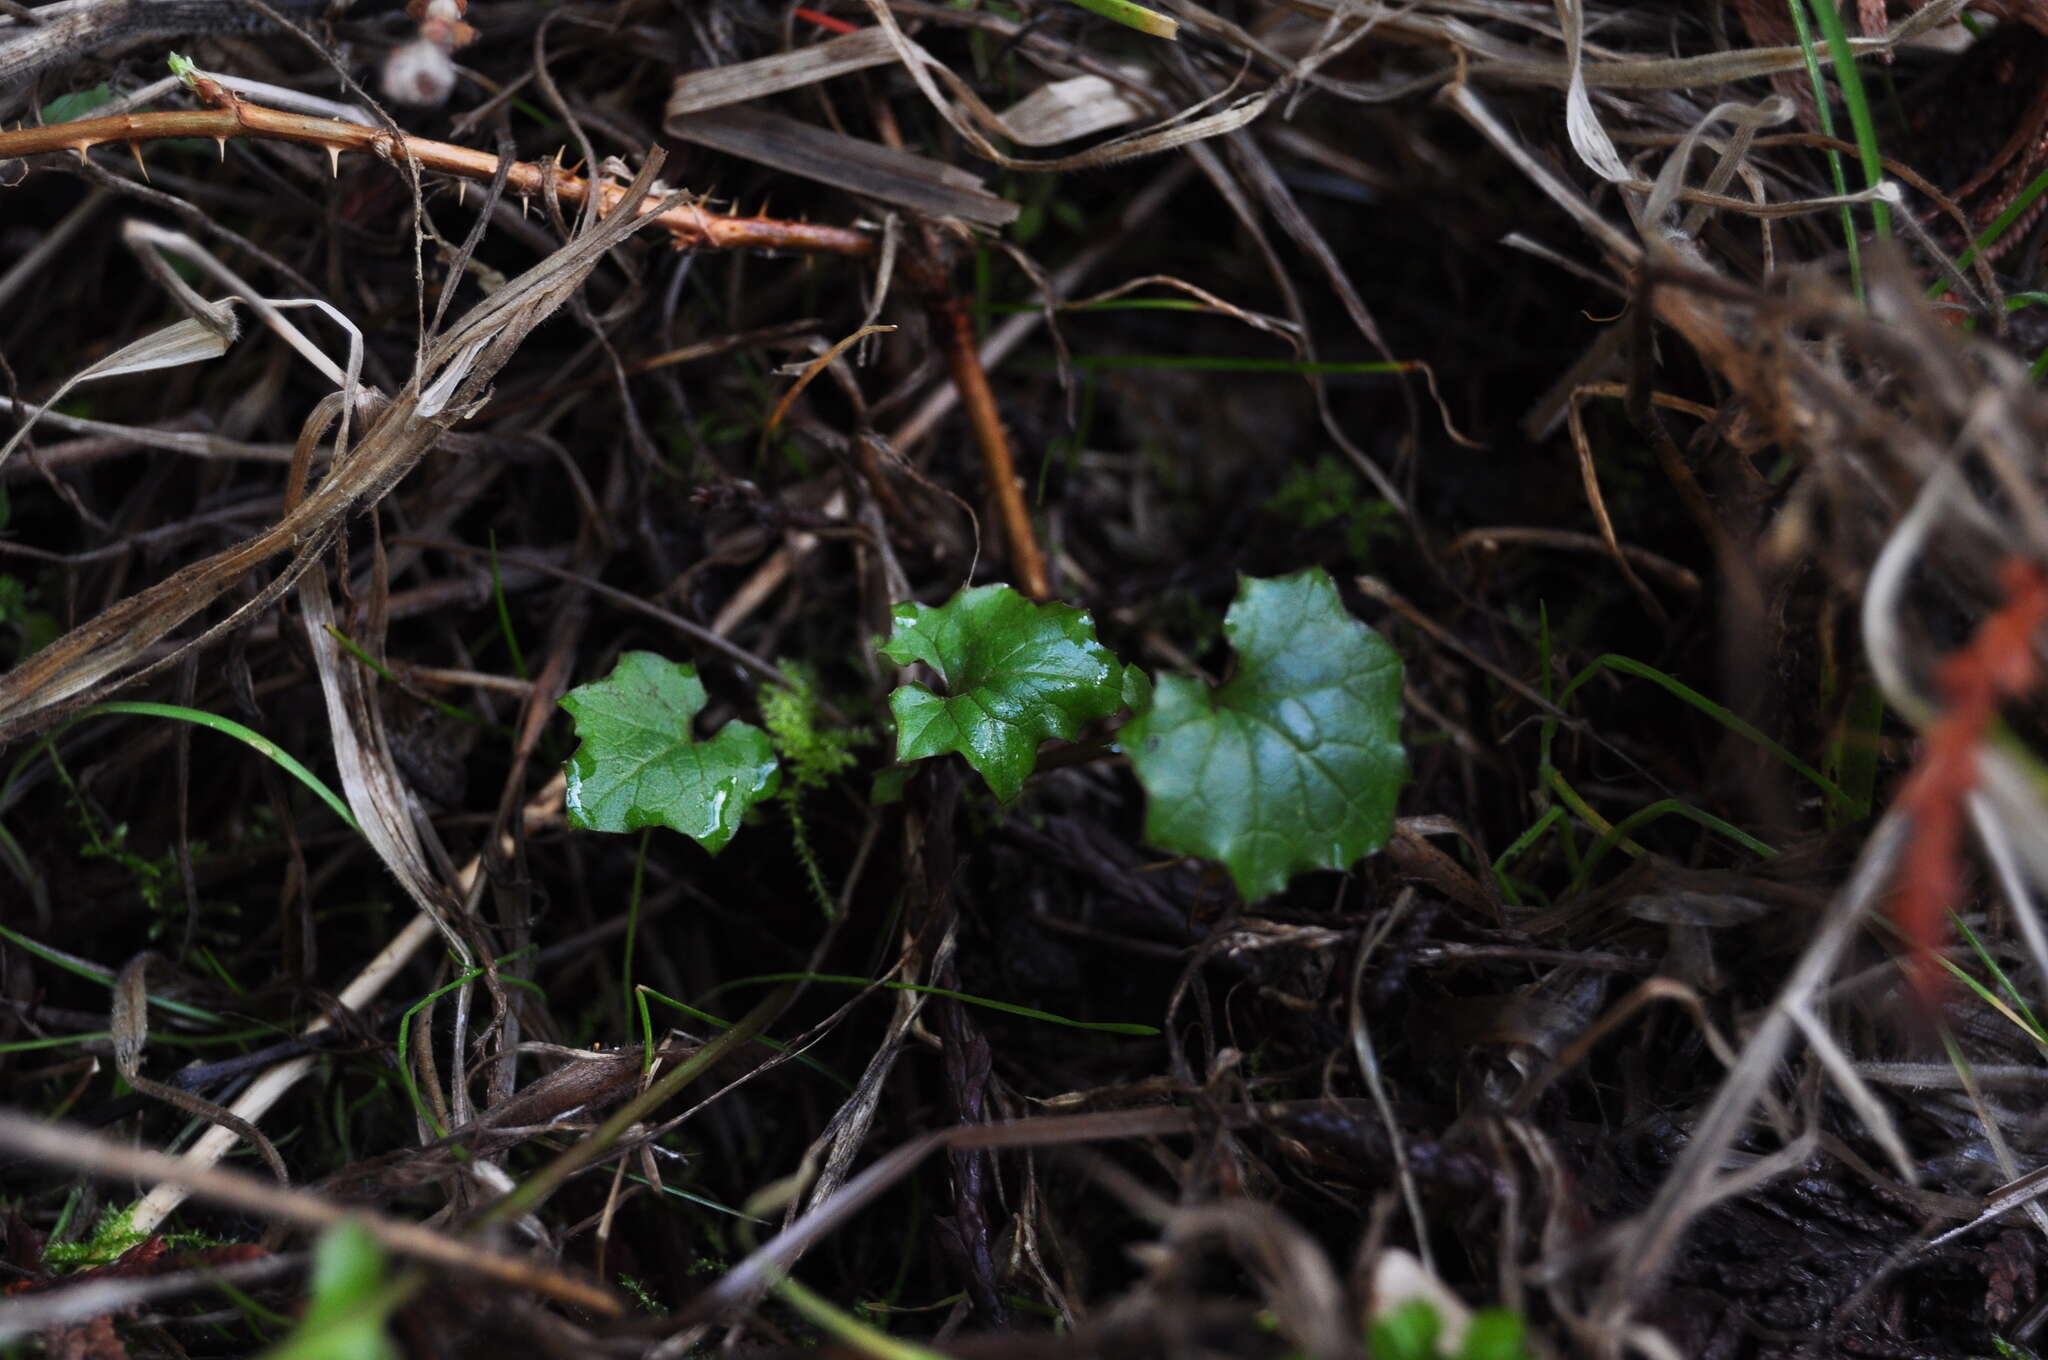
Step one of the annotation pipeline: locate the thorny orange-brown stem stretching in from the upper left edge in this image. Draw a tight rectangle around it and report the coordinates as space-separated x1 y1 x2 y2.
0 63 874 258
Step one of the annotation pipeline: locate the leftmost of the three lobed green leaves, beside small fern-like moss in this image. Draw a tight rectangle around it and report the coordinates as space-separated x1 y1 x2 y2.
561 651 780 854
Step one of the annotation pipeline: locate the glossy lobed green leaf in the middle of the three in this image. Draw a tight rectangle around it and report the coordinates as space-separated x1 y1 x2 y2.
881 586 1124 803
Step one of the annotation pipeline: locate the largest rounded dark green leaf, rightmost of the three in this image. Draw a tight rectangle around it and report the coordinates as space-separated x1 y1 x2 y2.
1122 567 1407 901
